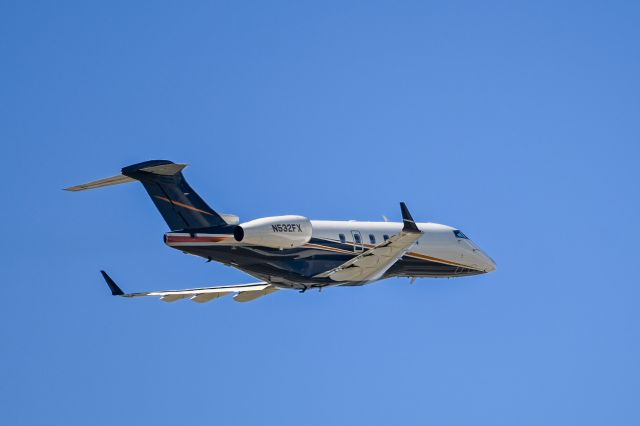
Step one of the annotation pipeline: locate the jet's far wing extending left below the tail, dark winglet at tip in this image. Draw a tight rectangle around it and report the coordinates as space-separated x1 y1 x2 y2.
100 271 278 303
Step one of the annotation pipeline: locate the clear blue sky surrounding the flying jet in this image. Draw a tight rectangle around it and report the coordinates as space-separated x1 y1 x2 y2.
0 1 640 426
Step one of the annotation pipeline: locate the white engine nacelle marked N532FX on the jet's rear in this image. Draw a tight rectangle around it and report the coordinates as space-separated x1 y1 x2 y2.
233 216 312 249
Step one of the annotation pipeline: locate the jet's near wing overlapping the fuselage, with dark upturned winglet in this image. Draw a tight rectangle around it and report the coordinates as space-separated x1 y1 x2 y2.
314 203 422 282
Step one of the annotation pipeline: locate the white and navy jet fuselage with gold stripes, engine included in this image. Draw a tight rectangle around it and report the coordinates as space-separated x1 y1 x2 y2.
165 215 496 288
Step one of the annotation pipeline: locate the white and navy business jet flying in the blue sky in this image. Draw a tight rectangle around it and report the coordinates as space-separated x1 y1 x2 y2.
65 160 496 303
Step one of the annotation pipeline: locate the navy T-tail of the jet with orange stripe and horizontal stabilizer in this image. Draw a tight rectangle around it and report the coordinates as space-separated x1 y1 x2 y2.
66 160 232 231
